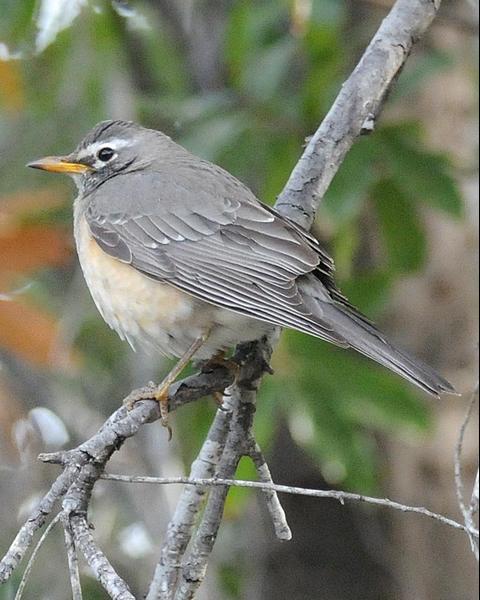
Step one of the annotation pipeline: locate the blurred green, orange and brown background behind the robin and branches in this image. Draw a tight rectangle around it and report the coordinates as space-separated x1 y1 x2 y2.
0 0 478 600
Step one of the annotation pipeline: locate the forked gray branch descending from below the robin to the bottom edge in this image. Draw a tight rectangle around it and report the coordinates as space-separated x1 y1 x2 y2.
147 339 278 600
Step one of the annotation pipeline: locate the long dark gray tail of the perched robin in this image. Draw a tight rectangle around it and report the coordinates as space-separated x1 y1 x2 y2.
304 284 457 397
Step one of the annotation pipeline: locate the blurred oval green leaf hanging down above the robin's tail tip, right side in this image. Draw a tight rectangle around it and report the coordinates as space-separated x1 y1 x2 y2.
372 179 427 273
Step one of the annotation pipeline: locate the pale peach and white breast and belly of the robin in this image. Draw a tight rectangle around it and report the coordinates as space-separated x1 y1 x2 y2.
75 216 271 359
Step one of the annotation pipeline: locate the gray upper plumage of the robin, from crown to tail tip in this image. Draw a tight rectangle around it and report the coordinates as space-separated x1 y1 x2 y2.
49 121 454 395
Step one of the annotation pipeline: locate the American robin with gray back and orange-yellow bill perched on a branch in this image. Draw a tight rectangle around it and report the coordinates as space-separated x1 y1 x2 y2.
29 121 454 416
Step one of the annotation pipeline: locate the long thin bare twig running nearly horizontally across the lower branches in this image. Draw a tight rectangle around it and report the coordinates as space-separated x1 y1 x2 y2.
102 473 479 538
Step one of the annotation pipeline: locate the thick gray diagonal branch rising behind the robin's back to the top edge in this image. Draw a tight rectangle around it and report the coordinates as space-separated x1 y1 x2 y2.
276 0 441 229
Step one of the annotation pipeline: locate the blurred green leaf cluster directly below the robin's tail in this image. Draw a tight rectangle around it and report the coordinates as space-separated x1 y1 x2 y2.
269 331 429 490
